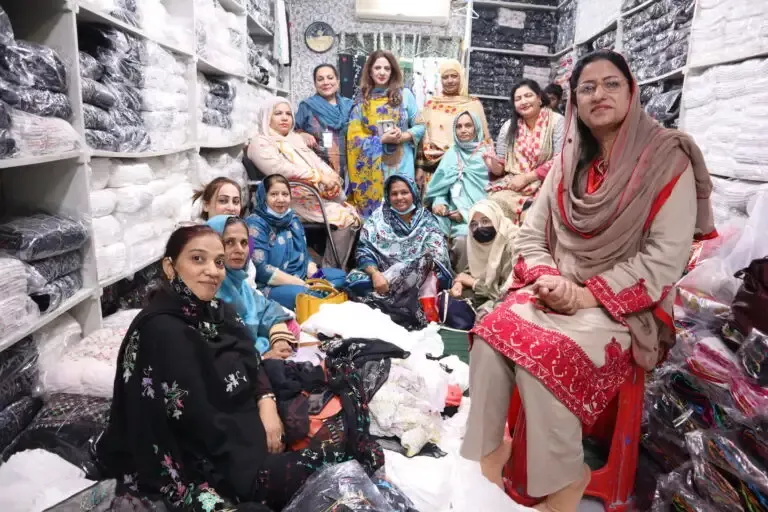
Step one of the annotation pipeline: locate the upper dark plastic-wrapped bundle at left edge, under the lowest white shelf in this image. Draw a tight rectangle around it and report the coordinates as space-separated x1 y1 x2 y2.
0 338 38 410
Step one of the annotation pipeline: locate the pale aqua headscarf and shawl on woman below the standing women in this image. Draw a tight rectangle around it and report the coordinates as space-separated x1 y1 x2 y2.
424 111 488 238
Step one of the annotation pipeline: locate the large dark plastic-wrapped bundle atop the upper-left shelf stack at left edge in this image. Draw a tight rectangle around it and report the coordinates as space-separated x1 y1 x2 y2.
0 40 67 92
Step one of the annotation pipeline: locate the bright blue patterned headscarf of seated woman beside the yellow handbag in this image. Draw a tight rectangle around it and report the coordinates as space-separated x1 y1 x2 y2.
245 182 310 285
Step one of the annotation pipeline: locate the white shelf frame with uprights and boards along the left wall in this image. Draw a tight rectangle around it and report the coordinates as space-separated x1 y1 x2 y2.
0 0 289 351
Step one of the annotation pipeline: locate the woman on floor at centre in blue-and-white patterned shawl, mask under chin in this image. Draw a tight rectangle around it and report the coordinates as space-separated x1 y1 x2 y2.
347 175 452 324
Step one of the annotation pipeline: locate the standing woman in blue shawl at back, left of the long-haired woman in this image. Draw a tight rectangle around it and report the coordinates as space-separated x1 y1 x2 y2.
296 64 353 179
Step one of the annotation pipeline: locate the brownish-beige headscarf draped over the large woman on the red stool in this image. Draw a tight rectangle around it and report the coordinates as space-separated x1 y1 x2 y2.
549 59 716 369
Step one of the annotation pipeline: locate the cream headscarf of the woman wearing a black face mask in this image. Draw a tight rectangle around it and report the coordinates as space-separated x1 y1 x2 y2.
467 199 520 288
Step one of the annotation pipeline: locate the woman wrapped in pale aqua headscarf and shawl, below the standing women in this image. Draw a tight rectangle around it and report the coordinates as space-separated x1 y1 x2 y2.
424 112 488 269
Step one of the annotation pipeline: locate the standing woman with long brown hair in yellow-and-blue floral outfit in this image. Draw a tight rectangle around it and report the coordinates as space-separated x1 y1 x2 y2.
347 50 424 218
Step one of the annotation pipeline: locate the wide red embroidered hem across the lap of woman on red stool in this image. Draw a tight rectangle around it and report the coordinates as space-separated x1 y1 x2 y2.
472 294 632 426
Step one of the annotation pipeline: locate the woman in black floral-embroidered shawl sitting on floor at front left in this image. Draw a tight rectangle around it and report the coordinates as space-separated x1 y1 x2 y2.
97 225 381 512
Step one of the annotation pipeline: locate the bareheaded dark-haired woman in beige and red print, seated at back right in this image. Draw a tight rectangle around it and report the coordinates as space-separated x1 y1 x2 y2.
484 79 565 226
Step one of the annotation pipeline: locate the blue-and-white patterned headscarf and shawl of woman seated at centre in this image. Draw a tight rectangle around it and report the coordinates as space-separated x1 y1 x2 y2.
357 174 452 283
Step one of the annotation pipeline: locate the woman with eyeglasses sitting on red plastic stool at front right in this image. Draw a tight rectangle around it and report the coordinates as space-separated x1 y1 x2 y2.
462 51 717 512
